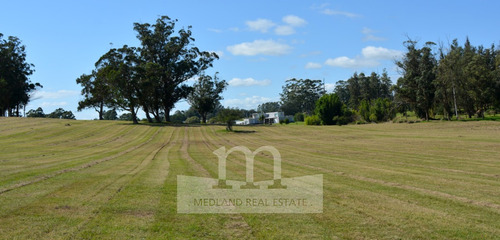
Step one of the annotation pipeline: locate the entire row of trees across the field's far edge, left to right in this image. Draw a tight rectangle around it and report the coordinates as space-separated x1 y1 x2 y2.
5 20 500 128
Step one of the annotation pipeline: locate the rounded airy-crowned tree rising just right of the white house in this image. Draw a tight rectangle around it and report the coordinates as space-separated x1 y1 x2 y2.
280 78 326 115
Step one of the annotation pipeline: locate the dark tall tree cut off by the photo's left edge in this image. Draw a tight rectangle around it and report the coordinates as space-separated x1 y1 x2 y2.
0 33 42 116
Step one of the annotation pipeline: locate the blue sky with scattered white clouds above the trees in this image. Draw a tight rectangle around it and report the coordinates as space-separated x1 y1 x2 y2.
0 0 500 119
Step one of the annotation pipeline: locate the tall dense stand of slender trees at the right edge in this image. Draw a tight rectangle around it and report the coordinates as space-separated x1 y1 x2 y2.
394 39 500 120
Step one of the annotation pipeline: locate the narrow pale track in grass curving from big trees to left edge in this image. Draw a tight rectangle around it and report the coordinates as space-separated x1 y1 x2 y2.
0 126 160 195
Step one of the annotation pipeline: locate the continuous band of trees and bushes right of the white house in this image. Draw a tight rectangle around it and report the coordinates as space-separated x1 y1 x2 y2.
259 39 500 125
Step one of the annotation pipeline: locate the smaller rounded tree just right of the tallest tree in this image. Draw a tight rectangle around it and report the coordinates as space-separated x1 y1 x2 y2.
188 73 227 123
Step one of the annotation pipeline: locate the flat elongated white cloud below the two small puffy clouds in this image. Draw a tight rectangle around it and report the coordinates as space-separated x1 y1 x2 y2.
227 40 291 56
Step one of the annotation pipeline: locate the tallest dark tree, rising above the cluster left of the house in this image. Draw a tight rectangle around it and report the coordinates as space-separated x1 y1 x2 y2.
134 16 218 121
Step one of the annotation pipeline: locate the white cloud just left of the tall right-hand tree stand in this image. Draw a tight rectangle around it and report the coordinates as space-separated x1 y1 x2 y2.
325 46 402 68
